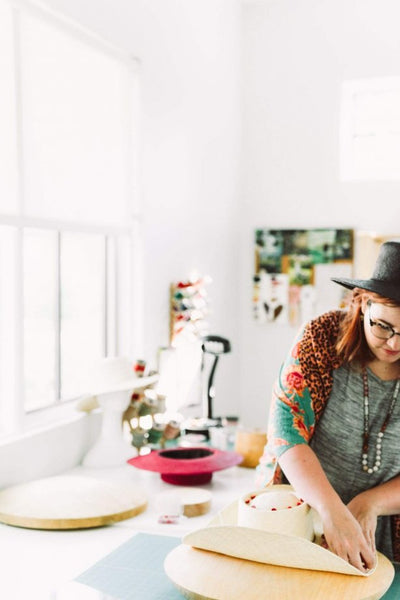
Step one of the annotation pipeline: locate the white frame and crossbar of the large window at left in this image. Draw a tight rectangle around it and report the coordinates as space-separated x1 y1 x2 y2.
0 0 143 439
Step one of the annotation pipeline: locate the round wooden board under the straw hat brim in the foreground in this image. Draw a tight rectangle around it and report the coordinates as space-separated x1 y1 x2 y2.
164 544 394 600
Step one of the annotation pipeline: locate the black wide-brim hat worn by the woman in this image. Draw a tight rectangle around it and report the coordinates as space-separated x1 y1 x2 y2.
332 242 400 302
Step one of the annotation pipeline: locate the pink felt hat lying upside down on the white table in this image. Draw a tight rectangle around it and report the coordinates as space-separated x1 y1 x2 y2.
128 447 243 485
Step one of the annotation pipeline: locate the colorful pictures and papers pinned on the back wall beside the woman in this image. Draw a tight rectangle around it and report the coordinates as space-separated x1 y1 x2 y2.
253 229 353 325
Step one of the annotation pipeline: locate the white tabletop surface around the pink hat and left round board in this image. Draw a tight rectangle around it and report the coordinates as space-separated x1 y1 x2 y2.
0 466 255 600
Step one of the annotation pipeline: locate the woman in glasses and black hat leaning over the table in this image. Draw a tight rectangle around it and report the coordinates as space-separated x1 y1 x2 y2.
258 242 400 571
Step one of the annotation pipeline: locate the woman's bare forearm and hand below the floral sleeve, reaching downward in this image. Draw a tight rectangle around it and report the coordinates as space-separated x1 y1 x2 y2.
279 444 376 571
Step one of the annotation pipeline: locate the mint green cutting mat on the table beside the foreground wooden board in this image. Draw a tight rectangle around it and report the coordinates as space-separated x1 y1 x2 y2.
75 533 184 600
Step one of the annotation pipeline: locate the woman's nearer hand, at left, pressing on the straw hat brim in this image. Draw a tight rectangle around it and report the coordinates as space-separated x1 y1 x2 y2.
320 505 376 572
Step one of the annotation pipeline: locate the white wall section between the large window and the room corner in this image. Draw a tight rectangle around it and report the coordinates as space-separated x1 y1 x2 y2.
37 0 241 414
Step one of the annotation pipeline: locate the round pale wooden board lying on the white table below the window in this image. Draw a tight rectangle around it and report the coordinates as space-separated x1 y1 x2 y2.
0 475 147 529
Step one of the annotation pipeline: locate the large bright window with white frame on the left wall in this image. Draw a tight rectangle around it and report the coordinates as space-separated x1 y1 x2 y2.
0 0 138 434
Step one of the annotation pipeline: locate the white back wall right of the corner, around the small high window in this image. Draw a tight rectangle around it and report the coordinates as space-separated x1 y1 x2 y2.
240 0 400 425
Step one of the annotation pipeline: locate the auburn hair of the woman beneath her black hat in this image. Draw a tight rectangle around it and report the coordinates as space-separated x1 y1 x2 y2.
336 288 400 365
